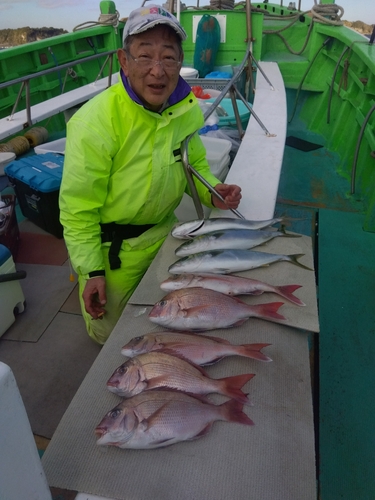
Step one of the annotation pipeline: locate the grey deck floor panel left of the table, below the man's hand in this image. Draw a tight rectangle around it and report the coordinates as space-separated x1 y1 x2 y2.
0 313 100 439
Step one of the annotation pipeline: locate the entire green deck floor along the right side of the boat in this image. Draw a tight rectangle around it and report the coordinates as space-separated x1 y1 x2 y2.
276 126 375 500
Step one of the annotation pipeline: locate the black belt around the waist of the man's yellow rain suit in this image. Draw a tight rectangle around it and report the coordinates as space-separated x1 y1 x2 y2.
100 222 155 269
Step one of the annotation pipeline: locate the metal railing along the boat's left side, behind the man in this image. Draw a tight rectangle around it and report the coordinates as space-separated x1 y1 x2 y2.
0 50 117 134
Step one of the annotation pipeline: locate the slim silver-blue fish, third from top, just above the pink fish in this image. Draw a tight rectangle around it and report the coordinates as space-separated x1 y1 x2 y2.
168 250 313 274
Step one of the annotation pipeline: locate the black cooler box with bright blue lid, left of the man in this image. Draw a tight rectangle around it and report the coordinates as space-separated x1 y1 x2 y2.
5 153 64 238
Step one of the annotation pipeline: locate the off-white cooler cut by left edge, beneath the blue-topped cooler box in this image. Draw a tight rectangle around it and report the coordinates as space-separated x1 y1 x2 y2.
0 245 26 336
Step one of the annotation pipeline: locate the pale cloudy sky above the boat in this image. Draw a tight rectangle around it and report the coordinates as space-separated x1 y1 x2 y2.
0 0 375 31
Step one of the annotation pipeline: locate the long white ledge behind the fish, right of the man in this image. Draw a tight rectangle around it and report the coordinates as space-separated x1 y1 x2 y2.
211 62 287 220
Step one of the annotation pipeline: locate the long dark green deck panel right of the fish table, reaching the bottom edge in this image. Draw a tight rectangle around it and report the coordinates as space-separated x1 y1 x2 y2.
319 210 375 500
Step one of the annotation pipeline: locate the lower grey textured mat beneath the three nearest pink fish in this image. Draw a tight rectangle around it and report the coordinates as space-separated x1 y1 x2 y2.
42 304 316 500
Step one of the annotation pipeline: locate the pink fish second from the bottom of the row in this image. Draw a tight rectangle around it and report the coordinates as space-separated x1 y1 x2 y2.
107 352 254 404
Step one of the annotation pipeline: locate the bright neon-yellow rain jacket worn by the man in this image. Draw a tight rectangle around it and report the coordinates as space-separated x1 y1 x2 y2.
60 77 220 278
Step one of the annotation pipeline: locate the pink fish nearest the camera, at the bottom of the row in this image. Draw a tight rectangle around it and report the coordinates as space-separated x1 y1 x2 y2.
95 391 254 449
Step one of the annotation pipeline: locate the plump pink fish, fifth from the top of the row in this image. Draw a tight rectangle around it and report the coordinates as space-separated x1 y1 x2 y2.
149 288 285 331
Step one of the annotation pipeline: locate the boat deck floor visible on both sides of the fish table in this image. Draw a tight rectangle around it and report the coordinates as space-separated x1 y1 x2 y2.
0 103 375 500
